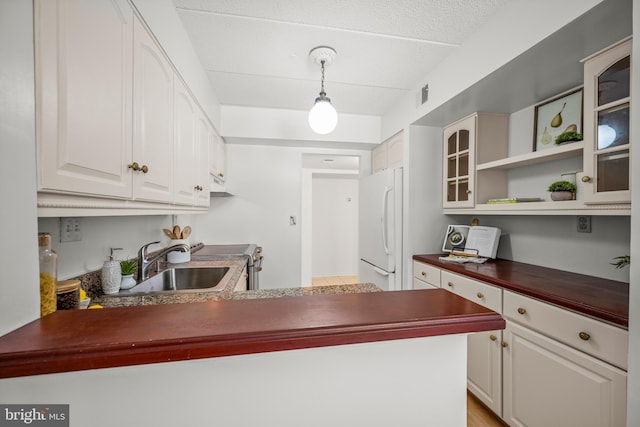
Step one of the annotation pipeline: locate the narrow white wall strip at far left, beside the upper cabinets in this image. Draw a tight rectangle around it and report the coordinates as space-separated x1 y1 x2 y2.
0 0 40 335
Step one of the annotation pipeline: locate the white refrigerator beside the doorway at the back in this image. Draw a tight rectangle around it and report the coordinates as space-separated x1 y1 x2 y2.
358 168 402 291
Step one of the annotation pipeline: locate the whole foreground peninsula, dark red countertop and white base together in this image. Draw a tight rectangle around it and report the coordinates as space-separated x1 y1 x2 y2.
0 289 504 426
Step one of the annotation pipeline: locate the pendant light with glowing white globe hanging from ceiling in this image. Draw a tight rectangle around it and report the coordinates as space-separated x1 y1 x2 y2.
309 46 338 135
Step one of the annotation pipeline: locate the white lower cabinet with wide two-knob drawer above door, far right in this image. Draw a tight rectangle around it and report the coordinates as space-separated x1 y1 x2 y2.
503 291 628 427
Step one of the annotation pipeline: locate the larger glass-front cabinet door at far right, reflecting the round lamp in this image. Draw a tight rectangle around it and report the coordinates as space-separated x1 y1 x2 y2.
582 39 631 203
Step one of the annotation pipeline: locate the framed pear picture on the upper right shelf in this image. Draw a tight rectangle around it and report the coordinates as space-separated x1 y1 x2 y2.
533 88 582 151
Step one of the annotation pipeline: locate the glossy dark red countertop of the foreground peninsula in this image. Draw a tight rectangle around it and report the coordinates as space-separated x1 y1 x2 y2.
0 289 505 378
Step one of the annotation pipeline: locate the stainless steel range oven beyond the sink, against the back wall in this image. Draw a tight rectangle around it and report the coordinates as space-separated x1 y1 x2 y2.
191 243 263 290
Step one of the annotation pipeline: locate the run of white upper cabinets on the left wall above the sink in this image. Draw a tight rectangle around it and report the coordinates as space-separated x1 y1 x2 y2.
34 0 216 216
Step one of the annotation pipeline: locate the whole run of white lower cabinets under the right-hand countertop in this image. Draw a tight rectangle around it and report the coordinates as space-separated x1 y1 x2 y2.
432 262 628 427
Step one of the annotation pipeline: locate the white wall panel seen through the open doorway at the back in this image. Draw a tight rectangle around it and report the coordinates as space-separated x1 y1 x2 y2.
311 174 359 277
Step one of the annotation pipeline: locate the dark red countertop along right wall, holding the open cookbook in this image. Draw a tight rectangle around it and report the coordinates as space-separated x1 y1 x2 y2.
413 254 629 327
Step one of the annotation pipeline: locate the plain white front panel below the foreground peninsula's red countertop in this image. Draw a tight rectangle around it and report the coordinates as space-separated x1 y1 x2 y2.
0 334 467 427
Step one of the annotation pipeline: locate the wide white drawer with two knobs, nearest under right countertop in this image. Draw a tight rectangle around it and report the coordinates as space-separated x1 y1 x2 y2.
504 291 628 370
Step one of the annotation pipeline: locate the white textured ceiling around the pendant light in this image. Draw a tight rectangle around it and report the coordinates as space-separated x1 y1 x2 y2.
173 0 509 115
